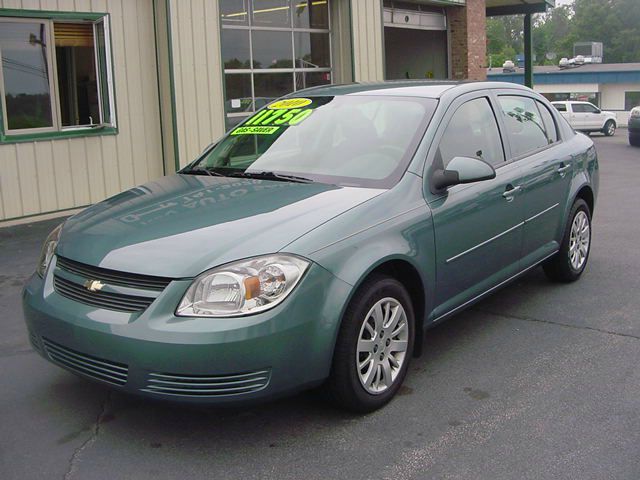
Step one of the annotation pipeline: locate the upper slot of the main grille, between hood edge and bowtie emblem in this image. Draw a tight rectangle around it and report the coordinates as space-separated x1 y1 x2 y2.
56 257 172 291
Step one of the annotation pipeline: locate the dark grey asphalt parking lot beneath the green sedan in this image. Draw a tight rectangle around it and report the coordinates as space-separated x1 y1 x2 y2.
0 130 640 480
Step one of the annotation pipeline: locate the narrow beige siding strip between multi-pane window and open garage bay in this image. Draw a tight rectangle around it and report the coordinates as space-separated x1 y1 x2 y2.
351 0 384 82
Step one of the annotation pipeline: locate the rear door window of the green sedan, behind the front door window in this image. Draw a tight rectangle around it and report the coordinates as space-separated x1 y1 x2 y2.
499 96 549 157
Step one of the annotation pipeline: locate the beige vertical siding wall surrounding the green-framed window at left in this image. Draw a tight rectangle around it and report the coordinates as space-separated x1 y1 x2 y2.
0 0 163 221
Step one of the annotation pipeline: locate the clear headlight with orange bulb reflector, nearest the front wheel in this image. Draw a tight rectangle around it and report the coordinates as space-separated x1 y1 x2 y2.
176 255 309 317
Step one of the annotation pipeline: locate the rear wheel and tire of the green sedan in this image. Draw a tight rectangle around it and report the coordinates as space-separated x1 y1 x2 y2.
542 198 591 283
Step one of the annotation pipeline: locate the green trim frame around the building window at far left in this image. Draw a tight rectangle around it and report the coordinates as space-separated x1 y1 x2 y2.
0 8 118 144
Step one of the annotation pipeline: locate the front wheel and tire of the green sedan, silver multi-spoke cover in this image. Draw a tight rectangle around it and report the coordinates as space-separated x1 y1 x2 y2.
323 274 415 413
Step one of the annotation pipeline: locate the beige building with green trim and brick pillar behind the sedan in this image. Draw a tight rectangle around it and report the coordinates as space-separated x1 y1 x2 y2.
0 0 554 225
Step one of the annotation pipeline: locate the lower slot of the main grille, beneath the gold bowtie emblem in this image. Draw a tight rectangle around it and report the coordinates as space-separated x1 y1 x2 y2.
53 275 155 313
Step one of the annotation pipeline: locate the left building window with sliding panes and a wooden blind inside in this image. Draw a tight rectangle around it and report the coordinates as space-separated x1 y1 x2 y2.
0 16 115 135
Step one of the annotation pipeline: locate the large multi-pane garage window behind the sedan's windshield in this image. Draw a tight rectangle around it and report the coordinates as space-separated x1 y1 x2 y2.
220 0 332 129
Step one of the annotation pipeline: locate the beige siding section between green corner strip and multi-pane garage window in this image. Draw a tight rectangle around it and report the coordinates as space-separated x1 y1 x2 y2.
169 0 224 171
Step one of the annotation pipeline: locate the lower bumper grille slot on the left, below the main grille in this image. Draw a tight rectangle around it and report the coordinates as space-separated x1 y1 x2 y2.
42 337 129 386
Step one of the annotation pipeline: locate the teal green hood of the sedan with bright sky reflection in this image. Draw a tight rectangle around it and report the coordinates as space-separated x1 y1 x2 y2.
56 174 382 278
